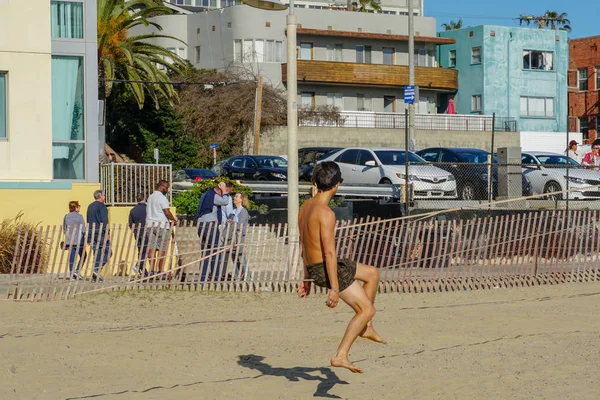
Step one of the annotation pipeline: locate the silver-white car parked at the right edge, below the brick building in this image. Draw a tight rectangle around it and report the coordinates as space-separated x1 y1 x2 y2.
521 151 600 199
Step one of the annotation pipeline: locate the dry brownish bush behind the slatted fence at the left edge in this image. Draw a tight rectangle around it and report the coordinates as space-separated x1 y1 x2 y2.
0 213 48 274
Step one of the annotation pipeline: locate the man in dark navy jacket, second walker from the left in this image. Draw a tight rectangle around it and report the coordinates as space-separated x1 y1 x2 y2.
87 190 111 282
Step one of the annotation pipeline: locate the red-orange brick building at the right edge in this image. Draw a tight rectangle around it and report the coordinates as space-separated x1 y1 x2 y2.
569 36 600 143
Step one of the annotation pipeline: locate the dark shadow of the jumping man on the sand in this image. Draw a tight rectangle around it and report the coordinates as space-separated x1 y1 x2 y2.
238 354 348 399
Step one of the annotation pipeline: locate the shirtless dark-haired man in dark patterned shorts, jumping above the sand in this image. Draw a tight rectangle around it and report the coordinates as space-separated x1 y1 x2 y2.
298 161 386 374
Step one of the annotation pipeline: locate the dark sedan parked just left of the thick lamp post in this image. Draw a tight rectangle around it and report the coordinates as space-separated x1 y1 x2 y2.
223 155 287 181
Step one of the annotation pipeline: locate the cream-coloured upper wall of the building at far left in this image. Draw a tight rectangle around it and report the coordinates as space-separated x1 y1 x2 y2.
0 0 52 180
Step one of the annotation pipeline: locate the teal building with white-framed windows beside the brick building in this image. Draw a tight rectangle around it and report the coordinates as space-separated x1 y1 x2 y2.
436 25 569 132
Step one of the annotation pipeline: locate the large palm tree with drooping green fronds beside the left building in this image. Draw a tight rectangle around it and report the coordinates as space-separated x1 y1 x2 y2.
98 0 185 109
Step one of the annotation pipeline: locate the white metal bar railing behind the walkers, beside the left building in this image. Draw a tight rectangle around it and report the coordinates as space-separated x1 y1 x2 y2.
100 163 173 206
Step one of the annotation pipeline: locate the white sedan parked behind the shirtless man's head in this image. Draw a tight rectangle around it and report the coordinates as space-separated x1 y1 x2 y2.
320 147 456 199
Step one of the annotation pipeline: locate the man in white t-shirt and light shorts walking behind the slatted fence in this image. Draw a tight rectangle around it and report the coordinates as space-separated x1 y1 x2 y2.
146 180 177 275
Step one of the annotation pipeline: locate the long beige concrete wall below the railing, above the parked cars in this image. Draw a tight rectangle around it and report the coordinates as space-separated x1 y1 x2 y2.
245 127 521 155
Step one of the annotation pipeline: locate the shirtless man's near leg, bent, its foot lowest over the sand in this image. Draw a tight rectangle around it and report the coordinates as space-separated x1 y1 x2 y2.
330 281 375 374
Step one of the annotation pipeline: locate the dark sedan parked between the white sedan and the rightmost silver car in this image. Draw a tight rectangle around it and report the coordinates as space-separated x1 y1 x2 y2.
417 147 532 200
